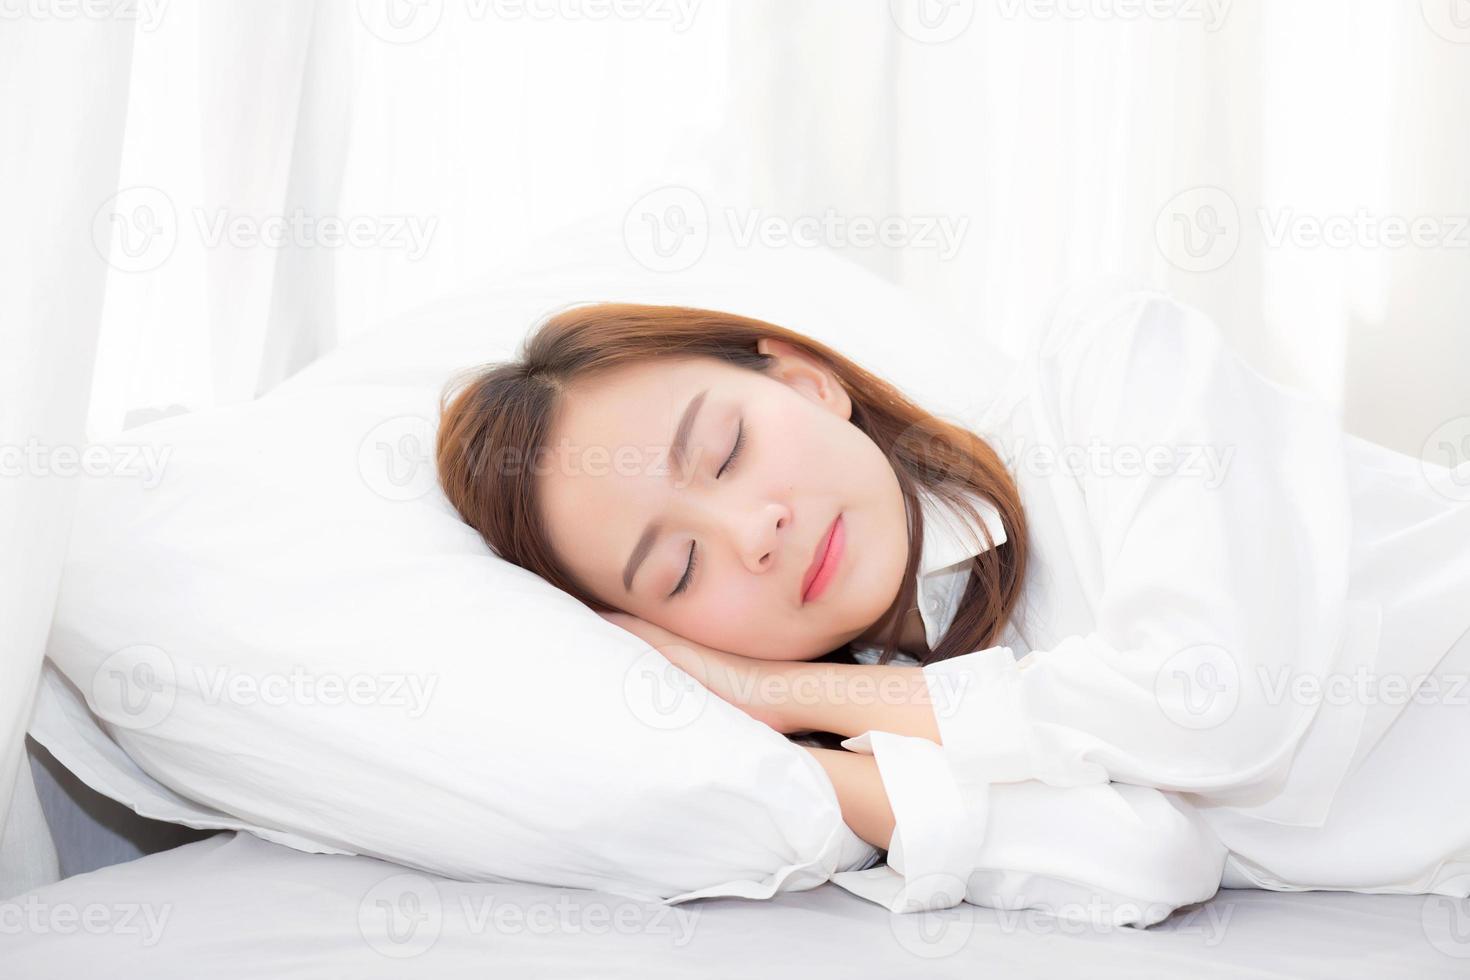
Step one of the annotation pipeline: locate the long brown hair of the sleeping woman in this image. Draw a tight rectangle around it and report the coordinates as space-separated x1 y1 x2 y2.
437 303 1028 664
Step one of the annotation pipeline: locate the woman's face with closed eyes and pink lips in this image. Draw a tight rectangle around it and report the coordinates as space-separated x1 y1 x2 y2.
538 339 908 660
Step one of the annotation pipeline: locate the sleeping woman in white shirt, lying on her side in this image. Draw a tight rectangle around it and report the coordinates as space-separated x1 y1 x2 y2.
438 292 1470 924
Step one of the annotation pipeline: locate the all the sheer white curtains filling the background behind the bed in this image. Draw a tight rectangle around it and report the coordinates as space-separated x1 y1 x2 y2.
0 0 1470 899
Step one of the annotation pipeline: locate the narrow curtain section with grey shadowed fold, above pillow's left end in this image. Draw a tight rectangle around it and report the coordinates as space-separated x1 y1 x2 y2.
90 0 357 433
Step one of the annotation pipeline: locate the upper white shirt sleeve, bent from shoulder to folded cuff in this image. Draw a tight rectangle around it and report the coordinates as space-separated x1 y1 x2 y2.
925 292 1361 823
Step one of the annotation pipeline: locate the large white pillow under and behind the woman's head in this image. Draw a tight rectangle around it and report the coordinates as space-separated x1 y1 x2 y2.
32 214 1008 901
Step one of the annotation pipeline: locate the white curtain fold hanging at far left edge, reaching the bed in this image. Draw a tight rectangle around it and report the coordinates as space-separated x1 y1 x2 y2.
0 7 135 896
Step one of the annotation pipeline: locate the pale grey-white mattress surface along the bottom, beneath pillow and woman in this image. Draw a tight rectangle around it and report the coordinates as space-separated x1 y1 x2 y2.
0 832 1470 980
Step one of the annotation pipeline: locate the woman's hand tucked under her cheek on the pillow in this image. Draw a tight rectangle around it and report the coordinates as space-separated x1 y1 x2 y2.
598 613 804 735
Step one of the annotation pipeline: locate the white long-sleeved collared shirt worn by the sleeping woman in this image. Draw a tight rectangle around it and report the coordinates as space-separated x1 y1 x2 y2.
832 292 1470 924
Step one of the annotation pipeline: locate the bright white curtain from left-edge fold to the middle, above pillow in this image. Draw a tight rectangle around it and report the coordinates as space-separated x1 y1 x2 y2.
90 0 740 433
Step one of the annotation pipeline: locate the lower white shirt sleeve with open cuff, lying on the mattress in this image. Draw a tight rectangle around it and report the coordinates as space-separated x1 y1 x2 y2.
832 732 1226 926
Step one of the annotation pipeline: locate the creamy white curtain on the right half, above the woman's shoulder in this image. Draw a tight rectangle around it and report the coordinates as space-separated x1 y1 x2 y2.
734 0 1470 455
